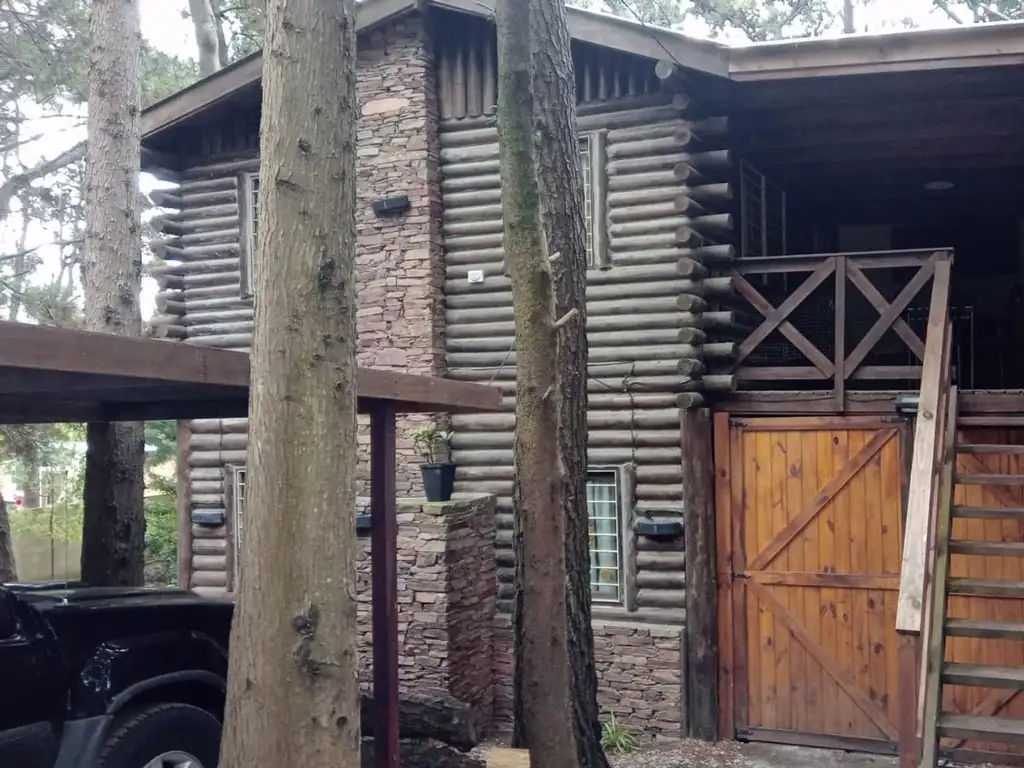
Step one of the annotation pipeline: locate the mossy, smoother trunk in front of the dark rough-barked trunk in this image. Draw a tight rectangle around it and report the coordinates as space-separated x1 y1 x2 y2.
498 2 581 768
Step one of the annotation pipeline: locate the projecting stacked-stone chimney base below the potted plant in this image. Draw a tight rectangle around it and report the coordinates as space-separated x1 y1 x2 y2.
356 496 498 720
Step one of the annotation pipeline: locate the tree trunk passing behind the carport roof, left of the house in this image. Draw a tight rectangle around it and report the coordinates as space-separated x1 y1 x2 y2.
82 0 145 586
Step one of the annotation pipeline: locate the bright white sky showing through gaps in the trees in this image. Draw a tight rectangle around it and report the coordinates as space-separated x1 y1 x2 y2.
0 0 991 317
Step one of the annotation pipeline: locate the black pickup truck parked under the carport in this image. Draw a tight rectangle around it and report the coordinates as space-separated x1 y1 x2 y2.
0 584 231 768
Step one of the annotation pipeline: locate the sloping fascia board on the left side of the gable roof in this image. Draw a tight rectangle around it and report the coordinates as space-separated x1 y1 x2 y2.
142 0 425 141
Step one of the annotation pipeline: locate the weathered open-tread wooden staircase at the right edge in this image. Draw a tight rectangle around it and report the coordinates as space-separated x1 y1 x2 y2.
920 388 1024 768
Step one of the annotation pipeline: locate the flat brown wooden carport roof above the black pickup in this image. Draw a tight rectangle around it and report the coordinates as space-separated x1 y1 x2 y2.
0 323 502 424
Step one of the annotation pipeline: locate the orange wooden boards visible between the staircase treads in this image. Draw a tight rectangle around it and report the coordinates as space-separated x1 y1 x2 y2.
942 427 1024 754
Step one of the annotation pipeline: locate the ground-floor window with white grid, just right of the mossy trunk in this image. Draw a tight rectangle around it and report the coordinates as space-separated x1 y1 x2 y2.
587 469 623 603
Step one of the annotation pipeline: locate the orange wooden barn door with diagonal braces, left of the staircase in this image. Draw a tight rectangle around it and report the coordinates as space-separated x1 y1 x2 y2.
715 414 904 751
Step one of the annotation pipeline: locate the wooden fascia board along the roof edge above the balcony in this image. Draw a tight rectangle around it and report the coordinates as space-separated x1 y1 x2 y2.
729 23 1024 82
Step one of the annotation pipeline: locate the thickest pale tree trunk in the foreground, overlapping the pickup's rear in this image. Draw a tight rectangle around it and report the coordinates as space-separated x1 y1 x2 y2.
220 0 360 768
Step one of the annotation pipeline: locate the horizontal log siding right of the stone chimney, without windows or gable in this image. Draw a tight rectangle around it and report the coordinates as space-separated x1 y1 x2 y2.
440 81 724 617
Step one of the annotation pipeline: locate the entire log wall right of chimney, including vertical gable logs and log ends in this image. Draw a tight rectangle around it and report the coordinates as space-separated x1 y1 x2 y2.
440 43 734 625
